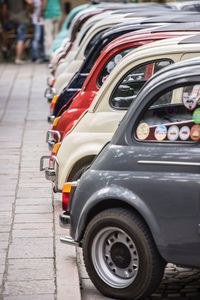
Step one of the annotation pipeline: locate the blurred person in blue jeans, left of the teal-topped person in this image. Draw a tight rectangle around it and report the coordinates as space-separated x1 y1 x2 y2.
32 0 45 62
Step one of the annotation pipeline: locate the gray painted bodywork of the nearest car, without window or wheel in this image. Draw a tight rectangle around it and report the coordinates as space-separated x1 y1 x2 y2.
70 59 200 267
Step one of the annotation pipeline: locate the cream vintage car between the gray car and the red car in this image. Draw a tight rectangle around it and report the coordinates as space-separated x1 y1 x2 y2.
41 36 200 191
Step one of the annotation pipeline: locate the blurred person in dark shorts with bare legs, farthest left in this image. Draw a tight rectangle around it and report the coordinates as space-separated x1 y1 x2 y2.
3 0 32 64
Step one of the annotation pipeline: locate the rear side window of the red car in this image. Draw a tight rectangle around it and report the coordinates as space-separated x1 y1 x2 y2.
97 47 136 88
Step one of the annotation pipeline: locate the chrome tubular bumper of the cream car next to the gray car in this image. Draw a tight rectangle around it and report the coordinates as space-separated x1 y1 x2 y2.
40 155 59 192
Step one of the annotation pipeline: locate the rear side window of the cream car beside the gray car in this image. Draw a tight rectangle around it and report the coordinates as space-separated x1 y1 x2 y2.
110 59 173 109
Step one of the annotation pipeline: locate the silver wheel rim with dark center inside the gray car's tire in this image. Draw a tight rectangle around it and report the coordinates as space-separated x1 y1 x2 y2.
91 227 139 289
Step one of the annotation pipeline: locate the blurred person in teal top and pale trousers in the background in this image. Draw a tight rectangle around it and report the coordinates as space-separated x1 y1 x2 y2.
43 0 62 59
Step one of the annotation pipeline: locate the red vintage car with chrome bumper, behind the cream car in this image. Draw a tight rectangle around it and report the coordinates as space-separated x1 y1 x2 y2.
47 31 200 149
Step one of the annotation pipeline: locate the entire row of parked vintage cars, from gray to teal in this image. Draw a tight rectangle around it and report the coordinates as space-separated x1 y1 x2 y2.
40 1 200 300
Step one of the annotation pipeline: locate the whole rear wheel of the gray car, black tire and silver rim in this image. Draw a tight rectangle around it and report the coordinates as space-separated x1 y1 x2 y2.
83 208 166 300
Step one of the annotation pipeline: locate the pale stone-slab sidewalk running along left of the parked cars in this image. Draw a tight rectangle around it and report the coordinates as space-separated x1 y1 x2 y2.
0 64 80 300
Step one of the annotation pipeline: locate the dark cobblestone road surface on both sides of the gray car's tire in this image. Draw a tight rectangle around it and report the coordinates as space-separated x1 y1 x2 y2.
77 245 200 300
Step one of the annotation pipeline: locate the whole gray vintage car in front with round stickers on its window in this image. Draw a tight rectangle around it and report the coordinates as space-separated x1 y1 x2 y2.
61 59 200 300
